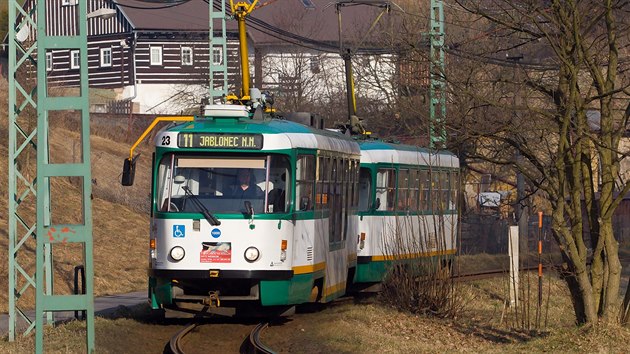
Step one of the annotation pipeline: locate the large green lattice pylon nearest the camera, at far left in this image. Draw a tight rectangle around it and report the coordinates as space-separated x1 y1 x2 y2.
8 0 94 353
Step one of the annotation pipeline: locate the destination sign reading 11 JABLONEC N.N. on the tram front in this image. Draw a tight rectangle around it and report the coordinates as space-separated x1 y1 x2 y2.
177 133 263 150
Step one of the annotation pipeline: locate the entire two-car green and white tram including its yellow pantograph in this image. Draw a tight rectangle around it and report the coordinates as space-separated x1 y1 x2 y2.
122 1 459 317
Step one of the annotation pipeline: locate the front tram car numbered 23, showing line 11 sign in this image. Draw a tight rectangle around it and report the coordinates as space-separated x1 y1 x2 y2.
149 105 360 316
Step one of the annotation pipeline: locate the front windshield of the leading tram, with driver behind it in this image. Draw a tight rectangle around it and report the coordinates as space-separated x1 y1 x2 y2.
156 154 291 214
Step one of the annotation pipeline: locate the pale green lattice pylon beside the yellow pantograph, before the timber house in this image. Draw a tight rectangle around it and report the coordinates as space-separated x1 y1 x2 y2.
208 0 228 104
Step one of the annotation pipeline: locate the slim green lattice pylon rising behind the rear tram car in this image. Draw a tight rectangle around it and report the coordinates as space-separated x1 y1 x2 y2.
429 0 446 149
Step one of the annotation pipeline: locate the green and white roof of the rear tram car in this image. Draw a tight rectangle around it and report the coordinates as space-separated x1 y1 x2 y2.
359 140 459 168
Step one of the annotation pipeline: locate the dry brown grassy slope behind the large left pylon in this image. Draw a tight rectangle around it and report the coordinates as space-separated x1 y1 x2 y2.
0 81 157 312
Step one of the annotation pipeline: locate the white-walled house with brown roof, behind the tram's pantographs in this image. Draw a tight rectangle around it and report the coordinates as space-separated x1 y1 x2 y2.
248 0 428 110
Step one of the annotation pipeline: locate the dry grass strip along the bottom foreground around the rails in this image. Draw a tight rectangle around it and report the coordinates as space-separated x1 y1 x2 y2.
0 278 630 353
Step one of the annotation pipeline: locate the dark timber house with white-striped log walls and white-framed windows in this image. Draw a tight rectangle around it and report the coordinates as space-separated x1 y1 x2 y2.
17 0 240 113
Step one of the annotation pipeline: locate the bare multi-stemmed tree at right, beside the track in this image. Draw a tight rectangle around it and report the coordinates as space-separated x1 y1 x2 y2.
447 0 630 324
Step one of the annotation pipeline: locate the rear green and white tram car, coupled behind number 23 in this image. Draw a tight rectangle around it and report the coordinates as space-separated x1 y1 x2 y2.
354 140 459 284
